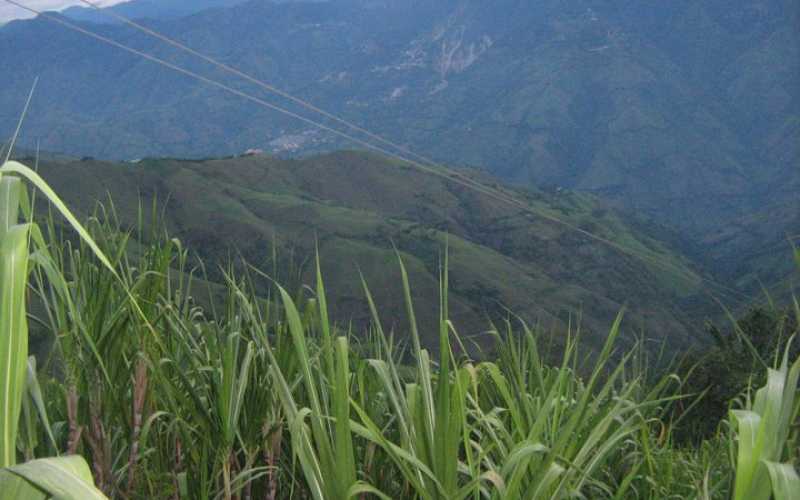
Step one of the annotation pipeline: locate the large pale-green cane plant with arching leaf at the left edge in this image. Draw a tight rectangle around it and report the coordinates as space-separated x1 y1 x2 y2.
0 161 113 500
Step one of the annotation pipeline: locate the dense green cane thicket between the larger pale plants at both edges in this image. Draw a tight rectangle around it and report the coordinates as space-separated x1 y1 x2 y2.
18 202 788 499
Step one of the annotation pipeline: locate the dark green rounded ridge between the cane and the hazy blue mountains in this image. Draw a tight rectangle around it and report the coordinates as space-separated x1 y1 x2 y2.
20 152 716 348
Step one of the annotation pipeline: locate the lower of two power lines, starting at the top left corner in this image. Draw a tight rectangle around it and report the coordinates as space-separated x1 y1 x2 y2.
4 0 752 303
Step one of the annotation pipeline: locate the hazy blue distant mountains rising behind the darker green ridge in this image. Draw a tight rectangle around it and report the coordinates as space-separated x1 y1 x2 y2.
0 0 800 336
